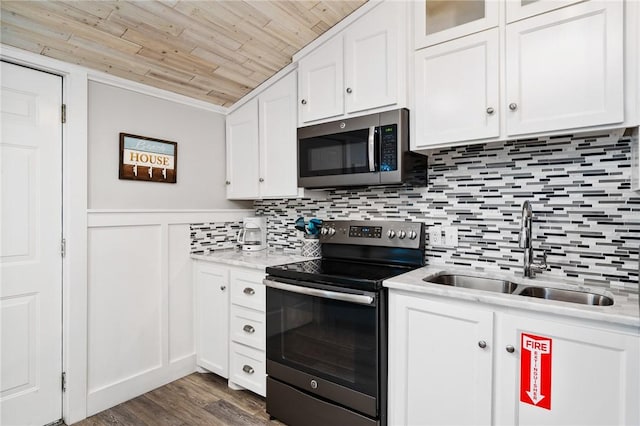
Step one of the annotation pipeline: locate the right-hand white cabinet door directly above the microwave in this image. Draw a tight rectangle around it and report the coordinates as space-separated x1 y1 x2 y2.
344 2 406 113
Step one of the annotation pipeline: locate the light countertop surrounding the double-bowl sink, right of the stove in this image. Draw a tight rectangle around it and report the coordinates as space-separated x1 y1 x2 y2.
384 265 640 332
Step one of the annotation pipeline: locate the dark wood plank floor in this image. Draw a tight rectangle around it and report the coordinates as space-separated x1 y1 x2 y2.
74 373 283 426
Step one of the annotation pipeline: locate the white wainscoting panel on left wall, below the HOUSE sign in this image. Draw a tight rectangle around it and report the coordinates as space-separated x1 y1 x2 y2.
87 209 253 416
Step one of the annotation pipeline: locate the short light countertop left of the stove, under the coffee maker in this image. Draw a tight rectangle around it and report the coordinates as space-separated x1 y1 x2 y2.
191 249 315 270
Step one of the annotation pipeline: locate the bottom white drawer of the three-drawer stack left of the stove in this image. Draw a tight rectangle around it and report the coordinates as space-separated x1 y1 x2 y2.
229 342 267 396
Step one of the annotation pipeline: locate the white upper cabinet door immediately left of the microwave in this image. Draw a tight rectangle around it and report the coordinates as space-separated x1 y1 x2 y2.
258 71 298 198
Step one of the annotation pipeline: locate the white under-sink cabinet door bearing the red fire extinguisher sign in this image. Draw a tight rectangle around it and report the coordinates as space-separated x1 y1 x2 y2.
495 314 640 426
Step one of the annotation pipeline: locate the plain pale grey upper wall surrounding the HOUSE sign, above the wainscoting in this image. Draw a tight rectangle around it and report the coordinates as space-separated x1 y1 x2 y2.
88 81 252 209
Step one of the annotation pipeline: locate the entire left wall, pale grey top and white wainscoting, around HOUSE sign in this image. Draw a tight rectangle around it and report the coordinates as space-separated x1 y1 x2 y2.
87 81 252 416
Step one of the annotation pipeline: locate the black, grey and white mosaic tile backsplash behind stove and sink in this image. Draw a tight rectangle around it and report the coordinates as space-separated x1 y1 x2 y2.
192 134 640 292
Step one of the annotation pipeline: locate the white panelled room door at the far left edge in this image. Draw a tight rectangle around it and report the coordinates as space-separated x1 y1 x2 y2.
0 62 62 426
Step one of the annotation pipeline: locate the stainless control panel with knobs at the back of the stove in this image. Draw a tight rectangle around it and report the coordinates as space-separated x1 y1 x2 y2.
320 220 425 249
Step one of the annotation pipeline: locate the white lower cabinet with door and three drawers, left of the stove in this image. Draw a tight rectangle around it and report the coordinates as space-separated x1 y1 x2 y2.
194 261 266 396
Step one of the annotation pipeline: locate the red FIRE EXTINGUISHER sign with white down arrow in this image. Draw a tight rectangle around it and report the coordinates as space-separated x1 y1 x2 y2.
520 333 553 410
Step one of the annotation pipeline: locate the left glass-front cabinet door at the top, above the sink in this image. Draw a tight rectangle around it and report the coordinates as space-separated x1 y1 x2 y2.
414 0 500 49
